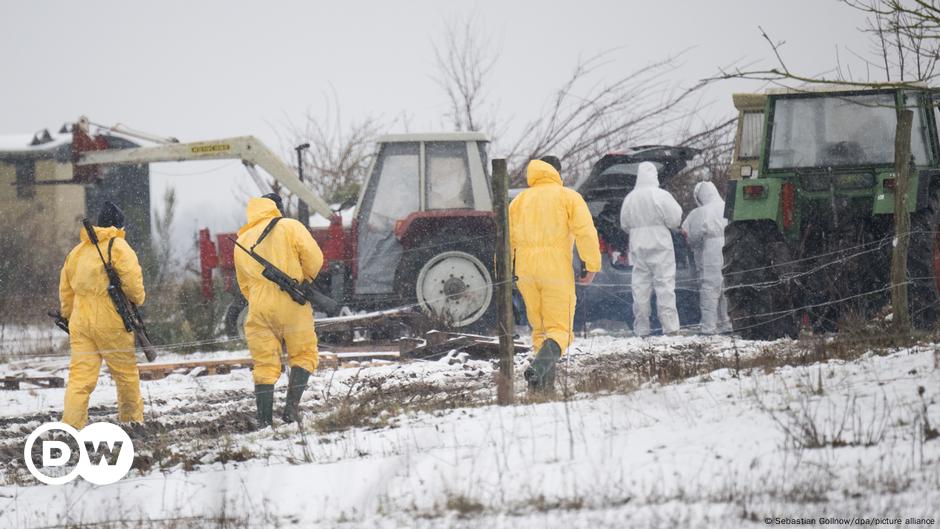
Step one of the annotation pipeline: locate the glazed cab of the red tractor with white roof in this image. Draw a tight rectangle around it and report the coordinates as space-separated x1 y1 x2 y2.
353 132 492 298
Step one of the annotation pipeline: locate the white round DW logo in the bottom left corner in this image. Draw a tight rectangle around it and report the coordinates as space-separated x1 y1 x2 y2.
23 422 134 485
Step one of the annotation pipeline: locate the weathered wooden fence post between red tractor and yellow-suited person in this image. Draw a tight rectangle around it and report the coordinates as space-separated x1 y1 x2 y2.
491 158 515 405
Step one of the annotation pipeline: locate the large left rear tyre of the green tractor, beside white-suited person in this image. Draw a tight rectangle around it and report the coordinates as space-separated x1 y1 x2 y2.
724 222 798 340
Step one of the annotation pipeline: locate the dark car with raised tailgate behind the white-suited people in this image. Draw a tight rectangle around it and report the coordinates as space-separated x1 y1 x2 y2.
574 145 699 332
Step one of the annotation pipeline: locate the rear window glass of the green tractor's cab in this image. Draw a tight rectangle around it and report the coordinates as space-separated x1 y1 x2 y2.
767 93 929 169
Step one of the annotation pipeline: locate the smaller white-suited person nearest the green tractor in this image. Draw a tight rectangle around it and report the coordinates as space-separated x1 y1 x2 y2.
682 182 732 334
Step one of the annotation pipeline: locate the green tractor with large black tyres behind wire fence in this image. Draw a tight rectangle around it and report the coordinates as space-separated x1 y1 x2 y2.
724 87 940 339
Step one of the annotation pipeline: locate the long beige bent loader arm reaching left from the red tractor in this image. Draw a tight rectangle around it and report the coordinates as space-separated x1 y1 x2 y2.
74 130 333 219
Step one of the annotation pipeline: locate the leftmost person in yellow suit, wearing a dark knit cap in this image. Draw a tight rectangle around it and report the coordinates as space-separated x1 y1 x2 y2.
59 202 144 430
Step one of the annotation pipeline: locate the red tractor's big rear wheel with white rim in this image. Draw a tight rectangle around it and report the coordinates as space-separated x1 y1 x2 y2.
398 237 496 333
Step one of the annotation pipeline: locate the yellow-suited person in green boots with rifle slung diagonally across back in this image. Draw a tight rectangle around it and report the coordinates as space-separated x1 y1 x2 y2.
235 193 323 428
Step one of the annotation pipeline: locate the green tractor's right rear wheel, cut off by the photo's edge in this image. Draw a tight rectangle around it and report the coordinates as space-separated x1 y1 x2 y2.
904 185 940 329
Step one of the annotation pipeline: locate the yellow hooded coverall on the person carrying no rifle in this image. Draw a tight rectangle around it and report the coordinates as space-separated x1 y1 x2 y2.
509 160 601 353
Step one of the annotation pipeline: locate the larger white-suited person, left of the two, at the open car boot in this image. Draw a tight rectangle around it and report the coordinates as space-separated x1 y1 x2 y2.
620 162 682 336
